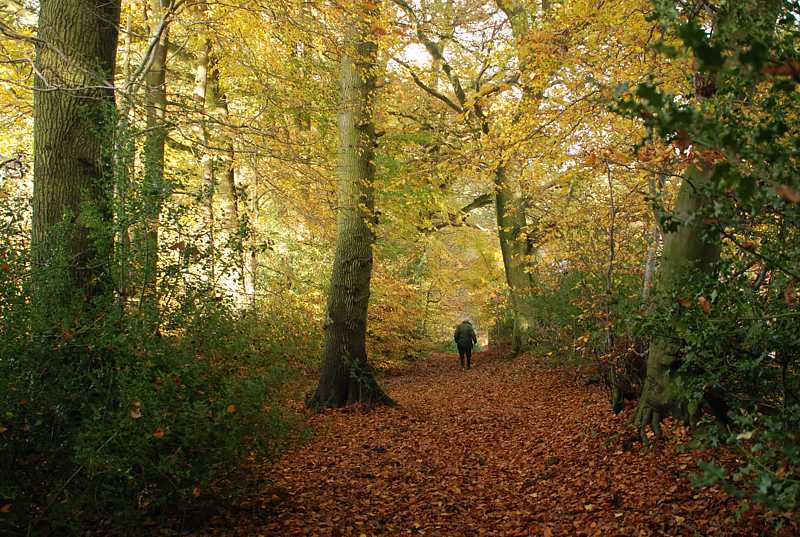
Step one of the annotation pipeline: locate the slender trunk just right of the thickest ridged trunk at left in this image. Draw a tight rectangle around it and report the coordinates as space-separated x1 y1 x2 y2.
141 0 169 318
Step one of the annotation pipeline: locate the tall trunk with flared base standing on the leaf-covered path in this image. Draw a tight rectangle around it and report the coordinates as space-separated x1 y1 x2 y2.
309 0 392 409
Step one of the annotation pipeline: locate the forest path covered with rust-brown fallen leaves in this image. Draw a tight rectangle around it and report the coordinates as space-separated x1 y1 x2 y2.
198 351 793 537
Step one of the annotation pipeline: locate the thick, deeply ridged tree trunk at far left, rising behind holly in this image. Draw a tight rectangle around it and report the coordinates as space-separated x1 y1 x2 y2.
32 0 120 320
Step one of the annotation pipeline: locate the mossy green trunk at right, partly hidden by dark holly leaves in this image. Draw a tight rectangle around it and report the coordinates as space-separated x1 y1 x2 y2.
635 166 721 438
